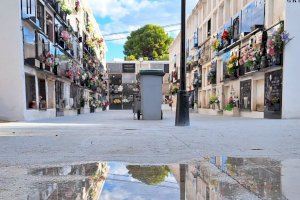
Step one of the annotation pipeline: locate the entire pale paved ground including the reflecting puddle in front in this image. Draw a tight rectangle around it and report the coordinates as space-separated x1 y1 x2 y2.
0 111 300 200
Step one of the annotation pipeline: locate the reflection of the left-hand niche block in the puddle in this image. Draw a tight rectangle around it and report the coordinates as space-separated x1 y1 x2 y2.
27 163 108 200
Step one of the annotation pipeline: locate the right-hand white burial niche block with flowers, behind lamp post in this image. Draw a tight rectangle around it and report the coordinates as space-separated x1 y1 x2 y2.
169 0 300 118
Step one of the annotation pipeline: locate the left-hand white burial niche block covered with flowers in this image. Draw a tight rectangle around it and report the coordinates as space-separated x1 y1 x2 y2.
0 0 107 121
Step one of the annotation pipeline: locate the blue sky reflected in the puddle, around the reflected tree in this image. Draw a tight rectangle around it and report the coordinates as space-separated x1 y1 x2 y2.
100 162 180 200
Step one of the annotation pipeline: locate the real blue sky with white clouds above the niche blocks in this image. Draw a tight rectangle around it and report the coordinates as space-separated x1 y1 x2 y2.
89 0 197 61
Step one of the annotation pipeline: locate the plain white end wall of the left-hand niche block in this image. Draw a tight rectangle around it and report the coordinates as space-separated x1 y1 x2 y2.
0 0 26 121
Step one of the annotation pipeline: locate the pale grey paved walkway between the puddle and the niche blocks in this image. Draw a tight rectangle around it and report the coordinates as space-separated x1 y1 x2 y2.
0 111 300 167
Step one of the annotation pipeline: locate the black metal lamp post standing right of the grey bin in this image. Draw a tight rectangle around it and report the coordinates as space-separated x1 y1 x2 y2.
175 0 190 126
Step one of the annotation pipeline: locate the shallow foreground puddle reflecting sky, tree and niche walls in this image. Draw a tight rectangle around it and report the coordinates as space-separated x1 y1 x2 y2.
27 156 300 200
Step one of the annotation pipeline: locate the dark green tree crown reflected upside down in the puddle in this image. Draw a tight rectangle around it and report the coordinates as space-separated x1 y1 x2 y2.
126 165 170 185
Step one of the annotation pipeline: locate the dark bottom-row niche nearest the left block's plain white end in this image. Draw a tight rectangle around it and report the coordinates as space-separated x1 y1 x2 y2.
25 74 37 109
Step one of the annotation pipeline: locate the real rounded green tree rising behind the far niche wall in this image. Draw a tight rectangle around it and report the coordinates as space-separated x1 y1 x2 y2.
124 24 173 60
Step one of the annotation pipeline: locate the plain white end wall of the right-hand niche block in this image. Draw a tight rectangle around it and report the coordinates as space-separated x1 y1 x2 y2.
282 1 300 118
